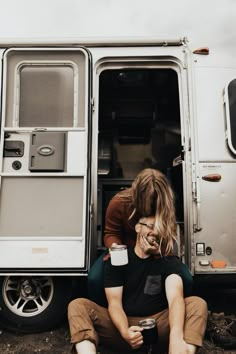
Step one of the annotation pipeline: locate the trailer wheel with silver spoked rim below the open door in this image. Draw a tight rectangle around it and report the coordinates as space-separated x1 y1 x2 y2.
0 276 71 333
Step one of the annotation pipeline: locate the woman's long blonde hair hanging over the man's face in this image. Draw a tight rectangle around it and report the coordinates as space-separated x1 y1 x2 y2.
130 168 176 254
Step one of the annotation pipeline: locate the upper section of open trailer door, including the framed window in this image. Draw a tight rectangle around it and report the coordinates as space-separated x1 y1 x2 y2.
3 48 87 129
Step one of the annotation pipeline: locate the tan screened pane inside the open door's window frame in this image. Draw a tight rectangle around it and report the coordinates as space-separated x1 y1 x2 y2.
19 65 74 127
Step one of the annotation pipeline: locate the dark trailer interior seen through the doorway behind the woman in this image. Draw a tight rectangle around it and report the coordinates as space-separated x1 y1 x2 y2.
98 68 183 246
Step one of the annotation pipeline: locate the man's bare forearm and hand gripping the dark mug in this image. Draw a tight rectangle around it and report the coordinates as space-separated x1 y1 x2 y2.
105 286 143 349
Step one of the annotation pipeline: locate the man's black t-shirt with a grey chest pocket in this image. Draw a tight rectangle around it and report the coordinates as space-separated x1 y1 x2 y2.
104 249 183 316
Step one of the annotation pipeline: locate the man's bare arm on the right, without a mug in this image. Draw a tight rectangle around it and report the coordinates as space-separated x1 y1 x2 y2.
165 274 190 354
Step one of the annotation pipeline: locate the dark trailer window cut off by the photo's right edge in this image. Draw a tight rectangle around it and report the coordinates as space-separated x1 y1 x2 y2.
226 79 236 155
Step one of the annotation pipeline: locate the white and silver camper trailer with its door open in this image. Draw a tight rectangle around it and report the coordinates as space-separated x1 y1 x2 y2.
0 38 236 331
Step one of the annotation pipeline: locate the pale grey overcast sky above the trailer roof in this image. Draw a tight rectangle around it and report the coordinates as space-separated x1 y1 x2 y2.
0 0 236 51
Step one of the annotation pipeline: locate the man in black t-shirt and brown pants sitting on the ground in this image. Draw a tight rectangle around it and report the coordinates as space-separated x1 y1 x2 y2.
68 217 207 354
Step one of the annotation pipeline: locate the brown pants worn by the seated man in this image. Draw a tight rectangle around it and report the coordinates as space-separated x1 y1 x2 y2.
68 296 207 351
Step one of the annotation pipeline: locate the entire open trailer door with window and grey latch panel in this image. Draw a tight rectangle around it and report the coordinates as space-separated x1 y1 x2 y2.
0 48 90 273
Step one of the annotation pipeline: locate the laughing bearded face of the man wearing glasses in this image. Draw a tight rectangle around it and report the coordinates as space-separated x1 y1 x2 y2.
136 217 160 255
